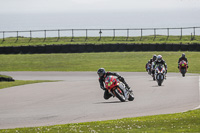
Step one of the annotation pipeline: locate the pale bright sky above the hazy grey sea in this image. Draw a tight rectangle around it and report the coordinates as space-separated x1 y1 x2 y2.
0 0 200 14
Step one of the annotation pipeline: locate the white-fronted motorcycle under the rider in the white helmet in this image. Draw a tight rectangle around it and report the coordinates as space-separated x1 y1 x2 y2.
155 64 166 86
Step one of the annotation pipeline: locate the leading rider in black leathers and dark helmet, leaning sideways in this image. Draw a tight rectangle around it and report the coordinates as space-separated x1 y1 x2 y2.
97 68 131 99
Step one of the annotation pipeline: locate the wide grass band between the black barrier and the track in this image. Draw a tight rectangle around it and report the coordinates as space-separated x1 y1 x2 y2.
0 52 200 73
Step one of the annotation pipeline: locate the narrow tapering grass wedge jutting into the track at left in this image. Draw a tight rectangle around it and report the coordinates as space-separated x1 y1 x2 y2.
0 80 56 89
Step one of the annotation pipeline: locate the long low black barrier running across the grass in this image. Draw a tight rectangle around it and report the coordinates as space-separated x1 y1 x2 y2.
0 44 200 54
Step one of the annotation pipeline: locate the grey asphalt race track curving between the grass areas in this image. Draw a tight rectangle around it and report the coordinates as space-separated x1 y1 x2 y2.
0 72 200 129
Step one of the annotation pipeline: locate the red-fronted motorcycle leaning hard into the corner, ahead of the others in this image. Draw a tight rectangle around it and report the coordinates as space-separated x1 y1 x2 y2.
105 76 134 102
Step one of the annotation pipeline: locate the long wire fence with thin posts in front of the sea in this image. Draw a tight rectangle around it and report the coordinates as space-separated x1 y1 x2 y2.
0 27 200 43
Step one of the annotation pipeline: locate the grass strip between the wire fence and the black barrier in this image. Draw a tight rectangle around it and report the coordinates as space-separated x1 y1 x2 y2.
0 35 200 46
